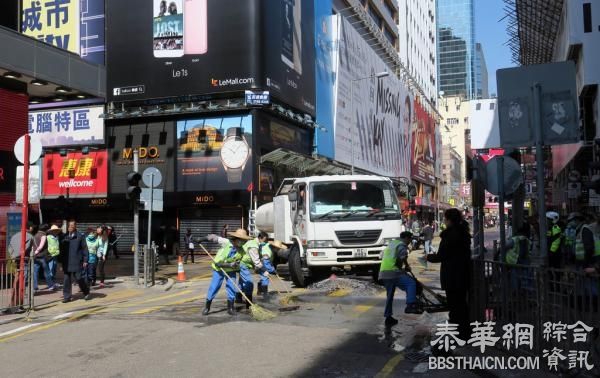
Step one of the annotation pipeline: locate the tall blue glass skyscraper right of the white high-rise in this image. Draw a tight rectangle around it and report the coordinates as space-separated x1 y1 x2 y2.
436 0 477 99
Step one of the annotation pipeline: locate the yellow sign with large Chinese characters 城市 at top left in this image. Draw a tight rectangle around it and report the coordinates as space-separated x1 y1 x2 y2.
21 0 79 54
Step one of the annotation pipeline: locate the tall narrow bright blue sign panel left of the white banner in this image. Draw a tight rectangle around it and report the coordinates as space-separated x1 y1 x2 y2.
314 0 335 159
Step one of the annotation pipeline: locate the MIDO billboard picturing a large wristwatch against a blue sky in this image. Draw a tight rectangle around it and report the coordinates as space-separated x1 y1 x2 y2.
177 115 253 192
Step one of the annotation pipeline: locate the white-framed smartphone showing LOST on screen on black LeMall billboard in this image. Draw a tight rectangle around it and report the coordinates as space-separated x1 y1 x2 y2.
152 0 184 58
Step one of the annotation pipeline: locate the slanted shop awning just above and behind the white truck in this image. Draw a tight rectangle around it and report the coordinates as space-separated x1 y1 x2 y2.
260 148 369 176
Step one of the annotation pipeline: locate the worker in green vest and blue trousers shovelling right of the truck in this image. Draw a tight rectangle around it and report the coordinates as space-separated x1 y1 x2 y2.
379 231 423 327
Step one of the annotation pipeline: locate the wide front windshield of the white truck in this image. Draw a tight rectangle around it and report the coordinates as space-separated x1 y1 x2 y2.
310 181 400 222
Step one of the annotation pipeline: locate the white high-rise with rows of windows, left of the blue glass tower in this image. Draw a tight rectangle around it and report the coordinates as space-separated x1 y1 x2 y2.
398 0 437 103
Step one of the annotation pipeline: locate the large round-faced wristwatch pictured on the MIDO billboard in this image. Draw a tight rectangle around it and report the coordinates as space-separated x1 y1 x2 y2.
221 127 250 183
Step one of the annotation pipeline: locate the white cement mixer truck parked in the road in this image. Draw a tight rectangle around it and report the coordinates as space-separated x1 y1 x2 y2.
256 175 402 287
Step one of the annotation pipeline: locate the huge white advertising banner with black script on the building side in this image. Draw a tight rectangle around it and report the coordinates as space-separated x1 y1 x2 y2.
335 16 414 177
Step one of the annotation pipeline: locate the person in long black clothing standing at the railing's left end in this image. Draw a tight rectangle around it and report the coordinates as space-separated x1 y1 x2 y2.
427 208 471 341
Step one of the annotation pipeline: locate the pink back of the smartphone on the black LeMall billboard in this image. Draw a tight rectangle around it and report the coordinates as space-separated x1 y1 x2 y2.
184 0 208 55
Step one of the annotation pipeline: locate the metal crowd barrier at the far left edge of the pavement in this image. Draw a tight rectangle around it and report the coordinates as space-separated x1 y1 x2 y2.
0 258 34 314
